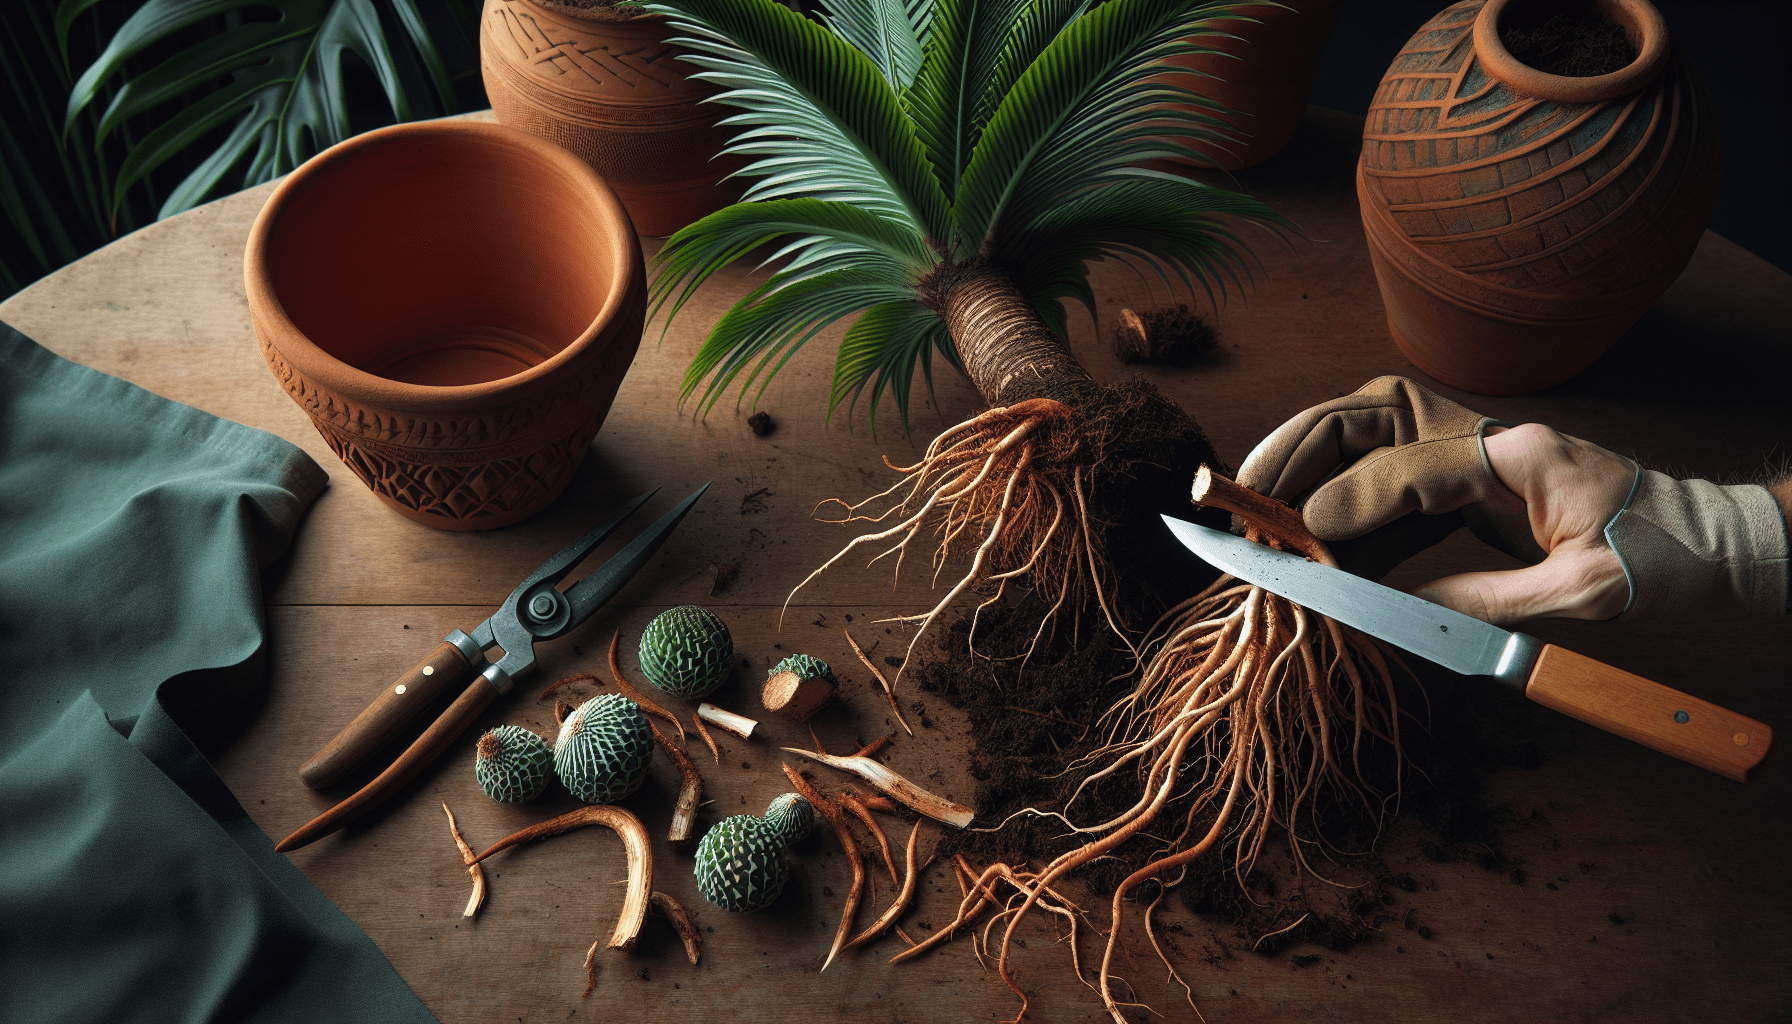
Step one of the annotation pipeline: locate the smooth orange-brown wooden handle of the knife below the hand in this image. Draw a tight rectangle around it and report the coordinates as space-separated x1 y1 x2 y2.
1525 644 1774 782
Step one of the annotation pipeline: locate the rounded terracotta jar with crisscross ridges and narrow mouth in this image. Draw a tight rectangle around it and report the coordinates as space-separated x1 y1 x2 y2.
1357 0 1719 395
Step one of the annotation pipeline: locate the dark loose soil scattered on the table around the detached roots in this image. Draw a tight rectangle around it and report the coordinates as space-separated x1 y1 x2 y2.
909 597 1519 963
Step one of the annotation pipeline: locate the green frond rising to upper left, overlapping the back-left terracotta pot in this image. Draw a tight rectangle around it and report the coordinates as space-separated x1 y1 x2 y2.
649 0 946 237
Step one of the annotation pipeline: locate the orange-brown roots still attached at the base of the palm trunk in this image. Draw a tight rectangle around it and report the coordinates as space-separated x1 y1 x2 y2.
785 398 1124 685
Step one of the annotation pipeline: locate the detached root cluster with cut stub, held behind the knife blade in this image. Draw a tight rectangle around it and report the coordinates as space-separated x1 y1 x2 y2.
953 468 1403 1024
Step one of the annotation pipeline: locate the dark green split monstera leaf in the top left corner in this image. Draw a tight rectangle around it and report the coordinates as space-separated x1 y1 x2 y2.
56 0 455 217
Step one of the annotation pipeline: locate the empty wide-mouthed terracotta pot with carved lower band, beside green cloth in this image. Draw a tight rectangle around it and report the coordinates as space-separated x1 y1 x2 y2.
244 120 645 529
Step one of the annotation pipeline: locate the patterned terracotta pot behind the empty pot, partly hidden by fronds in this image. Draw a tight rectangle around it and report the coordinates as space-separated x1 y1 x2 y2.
478 0 742 235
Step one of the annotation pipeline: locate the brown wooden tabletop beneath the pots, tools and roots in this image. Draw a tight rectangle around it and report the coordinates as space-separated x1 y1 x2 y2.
0 109 1792 1022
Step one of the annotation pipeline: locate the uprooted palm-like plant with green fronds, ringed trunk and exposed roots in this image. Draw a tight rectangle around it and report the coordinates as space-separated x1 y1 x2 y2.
650 0 1285 659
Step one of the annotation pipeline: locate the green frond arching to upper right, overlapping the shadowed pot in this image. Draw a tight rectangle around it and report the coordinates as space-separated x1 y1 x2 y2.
953 0 1261 246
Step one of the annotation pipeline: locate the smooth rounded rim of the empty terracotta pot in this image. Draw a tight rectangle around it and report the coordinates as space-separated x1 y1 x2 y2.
244 120 640 414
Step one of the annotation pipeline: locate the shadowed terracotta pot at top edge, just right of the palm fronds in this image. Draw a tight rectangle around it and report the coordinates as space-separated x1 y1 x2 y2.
1170 0 1344 170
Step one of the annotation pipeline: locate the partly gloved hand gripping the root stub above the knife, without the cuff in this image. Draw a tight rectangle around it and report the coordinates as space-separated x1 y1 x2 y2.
1238 377 1636 626
